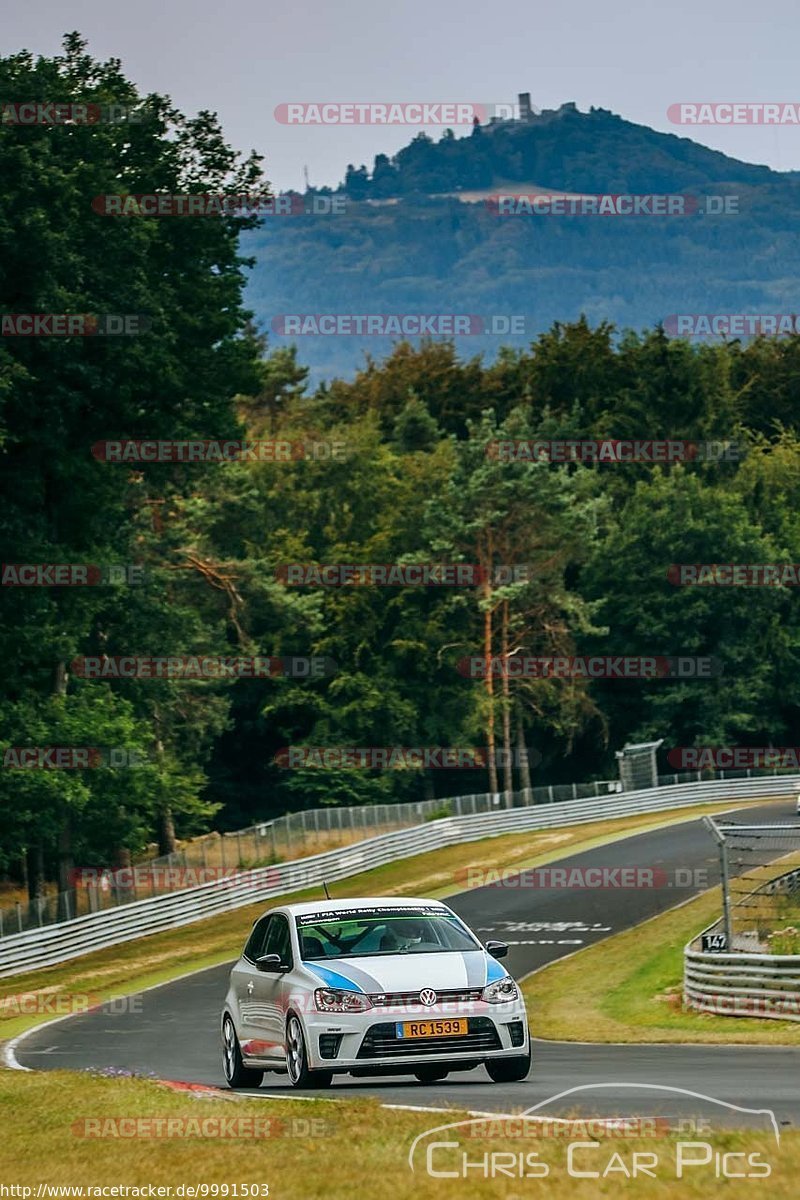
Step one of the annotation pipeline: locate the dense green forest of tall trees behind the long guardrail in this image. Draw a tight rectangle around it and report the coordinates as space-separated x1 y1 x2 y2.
0 36 800 902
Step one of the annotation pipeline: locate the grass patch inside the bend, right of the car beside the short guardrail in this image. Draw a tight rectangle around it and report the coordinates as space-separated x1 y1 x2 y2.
522 888 800 1045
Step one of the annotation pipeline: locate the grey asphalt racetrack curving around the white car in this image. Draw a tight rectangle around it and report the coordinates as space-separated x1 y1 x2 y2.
14 799 800 1128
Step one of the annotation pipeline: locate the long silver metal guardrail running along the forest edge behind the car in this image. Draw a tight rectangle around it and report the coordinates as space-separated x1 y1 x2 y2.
0 775 800 977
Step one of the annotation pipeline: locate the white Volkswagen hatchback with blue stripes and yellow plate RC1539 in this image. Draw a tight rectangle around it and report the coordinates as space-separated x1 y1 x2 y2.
222 899 530 1087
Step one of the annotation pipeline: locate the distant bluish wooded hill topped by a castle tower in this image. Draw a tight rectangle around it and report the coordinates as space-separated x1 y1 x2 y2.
242 104 800 379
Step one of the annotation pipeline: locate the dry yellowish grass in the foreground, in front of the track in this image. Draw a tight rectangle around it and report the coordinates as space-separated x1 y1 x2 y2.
0 1070 800 1200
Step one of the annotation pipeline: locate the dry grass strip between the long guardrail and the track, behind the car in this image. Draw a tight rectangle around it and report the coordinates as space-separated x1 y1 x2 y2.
0 799 777 1039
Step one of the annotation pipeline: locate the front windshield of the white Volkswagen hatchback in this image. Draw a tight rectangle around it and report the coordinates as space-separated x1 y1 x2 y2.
296 908 482 959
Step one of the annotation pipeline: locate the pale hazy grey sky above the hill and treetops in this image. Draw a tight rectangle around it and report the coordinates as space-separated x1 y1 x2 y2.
6 0 800 190
